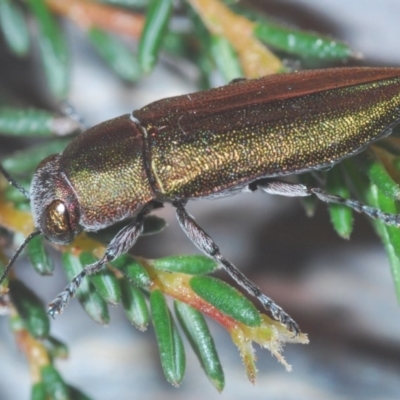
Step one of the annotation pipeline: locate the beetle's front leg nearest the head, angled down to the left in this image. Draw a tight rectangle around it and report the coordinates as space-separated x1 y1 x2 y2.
47 206 152 317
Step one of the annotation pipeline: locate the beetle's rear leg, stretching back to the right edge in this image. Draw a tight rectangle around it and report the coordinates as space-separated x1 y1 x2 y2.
255 180 400 227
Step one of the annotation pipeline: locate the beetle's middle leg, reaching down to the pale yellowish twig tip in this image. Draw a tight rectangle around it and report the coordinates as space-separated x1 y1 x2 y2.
173 202 300 335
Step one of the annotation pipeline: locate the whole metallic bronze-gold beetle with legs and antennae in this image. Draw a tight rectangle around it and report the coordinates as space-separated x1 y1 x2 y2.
0 68 400 334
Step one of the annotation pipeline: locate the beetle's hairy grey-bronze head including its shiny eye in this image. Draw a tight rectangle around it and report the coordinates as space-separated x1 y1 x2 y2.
30 155 82 244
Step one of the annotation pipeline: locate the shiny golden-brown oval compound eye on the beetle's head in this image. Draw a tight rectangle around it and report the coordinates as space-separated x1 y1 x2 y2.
41 200 74 244
